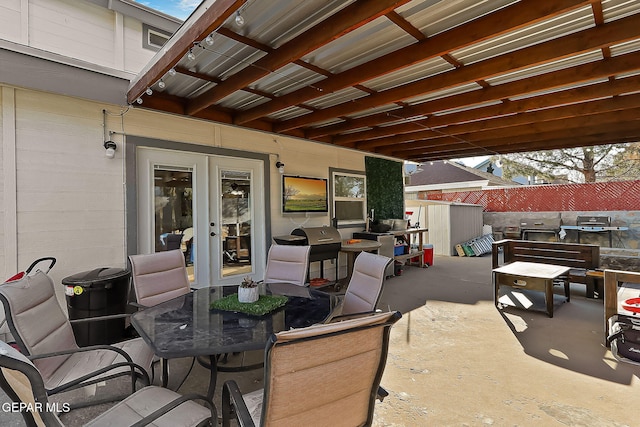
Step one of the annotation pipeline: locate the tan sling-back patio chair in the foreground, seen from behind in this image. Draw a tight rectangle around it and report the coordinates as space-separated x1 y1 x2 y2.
222 312 401 427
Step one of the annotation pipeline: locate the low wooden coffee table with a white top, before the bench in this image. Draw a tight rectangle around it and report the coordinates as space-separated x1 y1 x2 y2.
492 261 570 317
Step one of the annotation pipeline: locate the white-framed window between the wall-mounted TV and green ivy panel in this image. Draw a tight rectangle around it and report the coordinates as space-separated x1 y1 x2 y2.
332 171 367 226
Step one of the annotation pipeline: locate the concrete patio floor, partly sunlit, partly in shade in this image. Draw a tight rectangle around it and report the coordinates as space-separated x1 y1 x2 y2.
0 256 640 427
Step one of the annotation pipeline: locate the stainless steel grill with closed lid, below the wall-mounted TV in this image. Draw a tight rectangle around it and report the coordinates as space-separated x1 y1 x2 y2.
273 226 342 279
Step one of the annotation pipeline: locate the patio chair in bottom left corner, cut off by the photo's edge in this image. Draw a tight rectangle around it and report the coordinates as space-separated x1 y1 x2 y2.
0 341 217 427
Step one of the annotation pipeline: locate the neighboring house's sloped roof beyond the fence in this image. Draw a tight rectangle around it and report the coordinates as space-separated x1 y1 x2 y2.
407 160 518 189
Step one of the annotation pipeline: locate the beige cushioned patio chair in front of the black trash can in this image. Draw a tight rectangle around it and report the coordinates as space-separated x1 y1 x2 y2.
0 271 153 406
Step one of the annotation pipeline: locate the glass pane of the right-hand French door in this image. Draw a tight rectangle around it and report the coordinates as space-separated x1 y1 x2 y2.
220 170 252 277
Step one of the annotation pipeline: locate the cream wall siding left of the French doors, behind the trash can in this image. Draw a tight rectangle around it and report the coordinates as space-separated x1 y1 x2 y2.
16 90 125 283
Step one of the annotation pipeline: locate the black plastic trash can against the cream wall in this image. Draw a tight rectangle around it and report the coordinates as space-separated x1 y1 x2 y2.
62 267 131 347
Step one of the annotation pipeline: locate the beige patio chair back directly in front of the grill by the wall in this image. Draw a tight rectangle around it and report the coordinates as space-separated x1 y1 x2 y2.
263 245 311 286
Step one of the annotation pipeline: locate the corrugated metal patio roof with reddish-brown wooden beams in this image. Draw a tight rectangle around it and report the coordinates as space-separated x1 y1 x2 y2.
128 0 640 162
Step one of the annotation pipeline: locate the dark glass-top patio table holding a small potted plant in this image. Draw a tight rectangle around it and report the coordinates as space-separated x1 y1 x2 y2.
131 283 331 397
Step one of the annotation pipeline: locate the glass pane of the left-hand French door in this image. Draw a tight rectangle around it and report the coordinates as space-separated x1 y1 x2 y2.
153 166 195 282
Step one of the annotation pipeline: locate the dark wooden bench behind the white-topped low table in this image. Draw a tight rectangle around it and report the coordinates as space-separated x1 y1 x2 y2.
491 239 602 298
